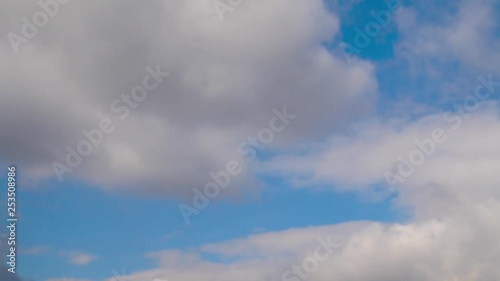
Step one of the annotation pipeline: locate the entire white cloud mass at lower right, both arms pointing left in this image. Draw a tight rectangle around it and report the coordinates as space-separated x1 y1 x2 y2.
105 102 500 281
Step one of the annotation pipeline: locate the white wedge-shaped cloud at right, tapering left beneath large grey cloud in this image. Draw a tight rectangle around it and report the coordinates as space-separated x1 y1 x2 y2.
263 100 500 203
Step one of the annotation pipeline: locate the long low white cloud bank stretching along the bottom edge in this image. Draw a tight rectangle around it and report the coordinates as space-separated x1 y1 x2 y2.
100 215 500 281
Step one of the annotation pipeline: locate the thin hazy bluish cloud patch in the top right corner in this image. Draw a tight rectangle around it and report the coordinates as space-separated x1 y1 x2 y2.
394 0 500 102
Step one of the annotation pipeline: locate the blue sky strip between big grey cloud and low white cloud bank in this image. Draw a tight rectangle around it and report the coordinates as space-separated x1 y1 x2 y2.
12 175 405 280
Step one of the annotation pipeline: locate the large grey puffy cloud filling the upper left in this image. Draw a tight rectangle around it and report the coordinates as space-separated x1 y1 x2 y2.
0 0 377 199
